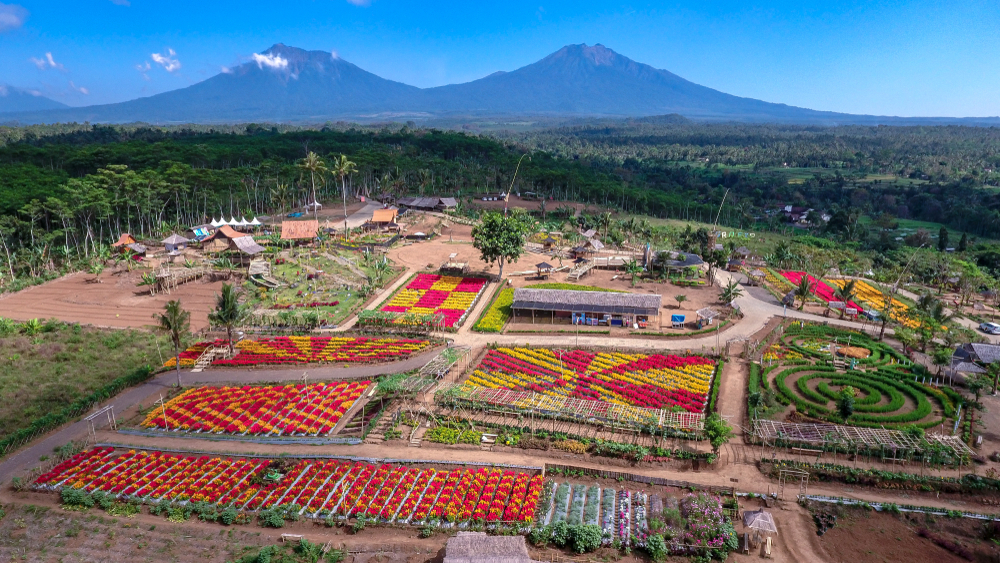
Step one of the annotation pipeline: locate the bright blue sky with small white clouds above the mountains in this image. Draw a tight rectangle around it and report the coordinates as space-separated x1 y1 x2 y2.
0 0 1000 117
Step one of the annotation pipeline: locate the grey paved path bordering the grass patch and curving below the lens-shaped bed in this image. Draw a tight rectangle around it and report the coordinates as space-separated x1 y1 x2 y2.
0 348 441 480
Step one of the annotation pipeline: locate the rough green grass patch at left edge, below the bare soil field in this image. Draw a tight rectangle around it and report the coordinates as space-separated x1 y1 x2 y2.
0 322 173 439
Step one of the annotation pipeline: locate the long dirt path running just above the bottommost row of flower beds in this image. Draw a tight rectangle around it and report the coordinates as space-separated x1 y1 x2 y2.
88 432 995 513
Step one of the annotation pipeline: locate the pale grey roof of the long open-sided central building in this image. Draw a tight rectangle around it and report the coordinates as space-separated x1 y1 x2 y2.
513 287 663 315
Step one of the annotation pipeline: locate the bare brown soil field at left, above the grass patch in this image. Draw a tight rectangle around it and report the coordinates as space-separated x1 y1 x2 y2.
0 271 223 332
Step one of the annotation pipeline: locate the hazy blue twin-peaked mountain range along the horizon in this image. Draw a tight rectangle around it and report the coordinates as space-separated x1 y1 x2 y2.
3 43 1000 125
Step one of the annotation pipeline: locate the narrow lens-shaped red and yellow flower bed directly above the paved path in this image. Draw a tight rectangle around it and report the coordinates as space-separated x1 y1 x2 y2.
163 336 431 367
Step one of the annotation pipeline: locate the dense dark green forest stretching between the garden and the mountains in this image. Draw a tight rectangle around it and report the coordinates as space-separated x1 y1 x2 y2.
0 116 1000 285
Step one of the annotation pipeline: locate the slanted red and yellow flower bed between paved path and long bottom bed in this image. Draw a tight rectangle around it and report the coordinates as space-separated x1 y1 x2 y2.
135 381 371 436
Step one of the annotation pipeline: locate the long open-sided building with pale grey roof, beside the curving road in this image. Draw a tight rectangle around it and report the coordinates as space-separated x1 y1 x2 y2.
511 287 663 327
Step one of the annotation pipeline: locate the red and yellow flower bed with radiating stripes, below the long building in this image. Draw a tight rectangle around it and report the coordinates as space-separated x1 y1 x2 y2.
468 348 715 412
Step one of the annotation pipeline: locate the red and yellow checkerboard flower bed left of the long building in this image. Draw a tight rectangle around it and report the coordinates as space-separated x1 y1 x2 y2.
380 274 486 328
